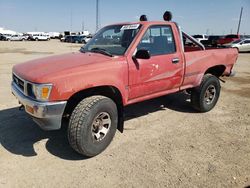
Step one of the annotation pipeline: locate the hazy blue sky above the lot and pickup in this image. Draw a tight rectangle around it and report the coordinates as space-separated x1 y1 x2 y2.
0 0 250 35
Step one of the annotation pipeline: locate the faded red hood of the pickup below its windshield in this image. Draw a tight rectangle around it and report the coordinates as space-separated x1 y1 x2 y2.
13 52 113 83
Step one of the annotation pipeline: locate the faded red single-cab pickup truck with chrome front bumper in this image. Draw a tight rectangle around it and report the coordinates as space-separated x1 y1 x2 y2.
12 11 238 157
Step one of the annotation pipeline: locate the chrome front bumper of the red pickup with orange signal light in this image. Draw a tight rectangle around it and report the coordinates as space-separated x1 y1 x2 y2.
11 82 67 130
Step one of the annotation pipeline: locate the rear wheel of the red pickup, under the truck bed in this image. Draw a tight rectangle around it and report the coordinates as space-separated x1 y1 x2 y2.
191 74 221 112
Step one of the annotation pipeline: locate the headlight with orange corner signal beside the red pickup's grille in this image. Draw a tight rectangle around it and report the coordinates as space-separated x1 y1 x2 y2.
32 84 52 101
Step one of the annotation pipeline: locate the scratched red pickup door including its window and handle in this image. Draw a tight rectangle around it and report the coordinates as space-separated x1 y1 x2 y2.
129 25 183 100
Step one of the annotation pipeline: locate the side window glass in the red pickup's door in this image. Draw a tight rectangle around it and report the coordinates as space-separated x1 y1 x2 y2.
137 26 176 56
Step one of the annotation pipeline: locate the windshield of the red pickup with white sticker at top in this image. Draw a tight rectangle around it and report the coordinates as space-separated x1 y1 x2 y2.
81 24 141 56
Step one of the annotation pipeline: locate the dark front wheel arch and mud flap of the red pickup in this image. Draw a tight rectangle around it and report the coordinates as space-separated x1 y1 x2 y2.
64 85 124 132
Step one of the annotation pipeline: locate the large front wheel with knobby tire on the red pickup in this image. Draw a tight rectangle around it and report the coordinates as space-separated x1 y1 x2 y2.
68 95 118 157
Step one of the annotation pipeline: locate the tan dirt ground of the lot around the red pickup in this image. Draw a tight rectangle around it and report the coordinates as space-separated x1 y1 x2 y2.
0 40 250 187
